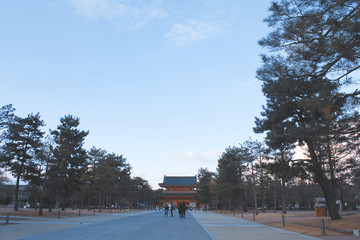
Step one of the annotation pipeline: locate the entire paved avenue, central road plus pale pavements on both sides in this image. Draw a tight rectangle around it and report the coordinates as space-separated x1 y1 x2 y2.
0 211 334 240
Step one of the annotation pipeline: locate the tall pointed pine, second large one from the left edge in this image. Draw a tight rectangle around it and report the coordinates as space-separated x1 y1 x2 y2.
49 115 89 210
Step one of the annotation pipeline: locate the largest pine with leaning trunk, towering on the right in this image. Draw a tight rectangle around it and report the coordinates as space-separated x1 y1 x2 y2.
255 0 360 219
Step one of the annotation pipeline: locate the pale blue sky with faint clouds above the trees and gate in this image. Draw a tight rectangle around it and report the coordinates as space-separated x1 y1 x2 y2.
0 0 271 188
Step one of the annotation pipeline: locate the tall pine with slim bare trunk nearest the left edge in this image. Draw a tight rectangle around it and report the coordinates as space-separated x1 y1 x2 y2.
0 113 44 211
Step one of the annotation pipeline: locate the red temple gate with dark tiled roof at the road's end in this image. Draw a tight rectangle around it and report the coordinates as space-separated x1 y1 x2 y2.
158 175 197 207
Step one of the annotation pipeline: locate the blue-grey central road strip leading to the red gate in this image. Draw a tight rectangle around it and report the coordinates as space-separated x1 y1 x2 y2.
16 211 212 240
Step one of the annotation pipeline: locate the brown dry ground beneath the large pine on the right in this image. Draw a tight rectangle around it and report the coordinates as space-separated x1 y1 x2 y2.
218 211 360 237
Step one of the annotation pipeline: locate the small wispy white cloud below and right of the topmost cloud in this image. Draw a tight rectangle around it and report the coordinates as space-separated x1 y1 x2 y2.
165 20 223 46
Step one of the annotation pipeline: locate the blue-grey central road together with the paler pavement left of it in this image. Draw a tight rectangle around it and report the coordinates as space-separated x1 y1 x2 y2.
0 211 211 240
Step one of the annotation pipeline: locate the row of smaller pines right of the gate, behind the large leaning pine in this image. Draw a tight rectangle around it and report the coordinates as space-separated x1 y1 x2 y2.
196 139 360 218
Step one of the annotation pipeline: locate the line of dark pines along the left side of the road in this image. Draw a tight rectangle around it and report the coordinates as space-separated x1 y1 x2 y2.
0 104 155 215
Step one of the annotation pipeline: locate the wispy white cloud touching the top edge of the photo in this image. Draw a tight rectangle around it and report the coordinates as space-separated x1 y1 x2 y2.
67 0 167 28
